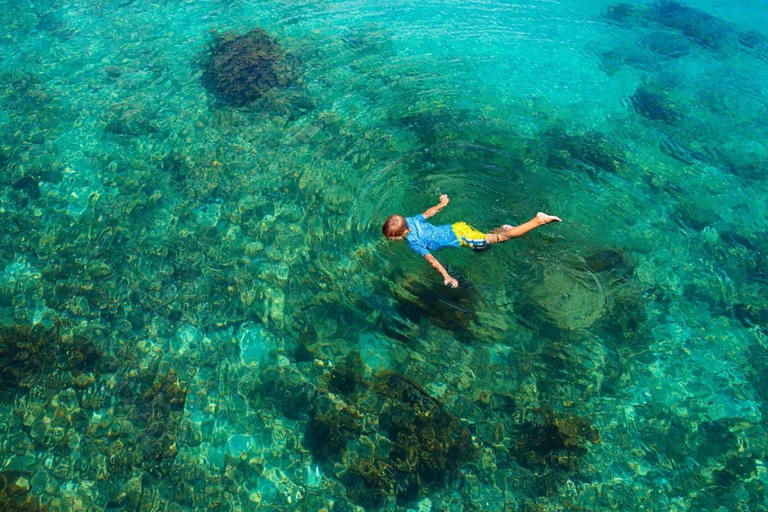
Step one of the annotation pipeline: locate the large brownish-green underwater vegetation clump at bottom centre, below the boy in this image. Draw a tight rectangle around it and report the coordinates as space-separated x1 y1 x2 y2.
305 360 477 507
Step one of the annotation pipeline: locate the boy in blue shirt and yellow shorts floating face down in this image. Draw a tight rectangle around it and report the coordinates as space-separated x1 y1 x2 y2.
381 194 562 288
